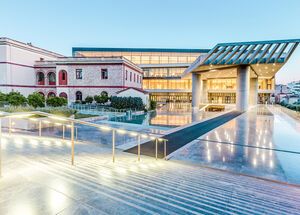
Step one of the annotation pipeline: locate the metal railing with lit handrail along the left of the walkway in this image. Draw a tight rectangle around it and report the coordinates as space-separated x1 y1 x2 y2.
0 111 167 176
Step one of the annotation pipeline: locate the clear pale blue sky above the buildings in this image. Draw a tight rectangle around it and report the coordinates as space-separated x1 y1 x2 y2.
0 0 300 83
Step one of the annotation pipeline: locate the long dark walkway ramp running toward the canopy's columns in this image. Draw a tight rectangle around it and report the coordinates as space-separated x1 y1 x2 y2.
125 111 242 158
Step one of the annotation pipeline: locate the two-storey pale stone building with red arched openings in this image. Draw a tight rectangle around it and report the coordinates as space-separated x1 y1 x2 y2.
35 57 143 103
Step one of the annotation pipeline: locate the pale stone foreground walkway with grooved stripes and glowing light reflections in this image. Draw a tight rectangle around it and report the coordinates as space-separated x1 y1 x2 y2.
0 136 300 215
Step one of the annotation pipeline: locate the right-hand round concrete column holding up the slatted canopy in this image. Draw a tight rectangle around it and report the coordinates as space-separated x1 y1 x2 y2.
236 65 250 111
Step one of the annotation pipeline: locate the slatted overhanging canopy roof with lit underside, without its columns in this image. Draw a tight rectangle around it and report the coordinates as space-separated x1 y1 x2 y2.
185 39 300 76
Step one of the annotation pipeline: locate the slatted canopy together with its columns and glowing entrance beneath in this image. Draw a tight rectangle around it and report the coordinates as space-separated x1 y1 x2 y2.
183 39 300 112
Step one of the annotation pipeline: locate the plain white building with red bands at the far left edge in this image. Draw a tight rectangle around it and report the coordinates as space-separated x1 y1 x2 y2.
0 37 63 96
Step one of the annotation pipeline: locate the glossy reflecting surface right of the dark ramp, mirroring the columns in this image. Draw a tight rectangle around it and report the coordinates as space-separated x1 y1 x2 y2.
172 106 300 184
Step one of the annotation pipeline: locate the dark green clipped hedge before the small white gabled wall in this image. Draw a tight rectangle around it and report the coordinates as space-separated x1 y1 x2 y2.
111 96 145 110
